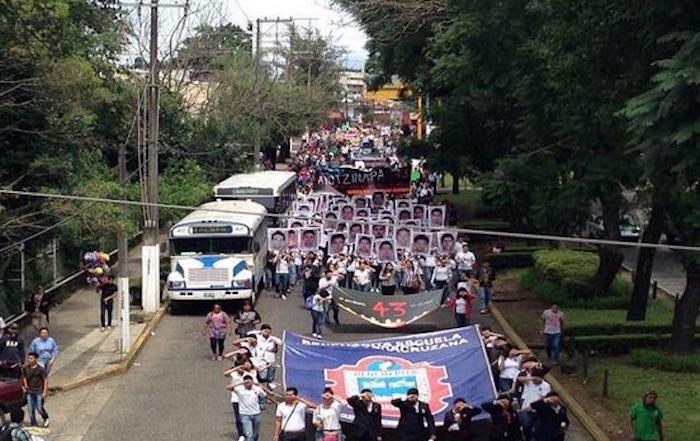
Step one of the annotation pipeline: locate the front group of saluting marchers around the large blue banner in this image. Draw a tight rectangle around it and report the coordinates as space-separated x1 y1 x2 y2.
204 300 569 441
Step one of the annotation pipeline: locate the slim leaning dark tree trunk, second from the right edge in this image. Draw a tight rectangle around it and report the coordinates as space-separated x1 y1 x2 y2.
627 203 664 321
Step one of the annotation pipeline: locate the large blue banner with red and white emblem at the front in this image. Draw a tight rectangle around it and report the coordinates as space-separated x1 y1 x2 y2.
283 326 496 427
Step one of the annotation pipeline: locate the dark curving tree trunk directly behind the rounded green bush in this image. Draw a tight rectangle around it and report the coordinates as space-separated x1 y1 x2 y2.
584 194 624 298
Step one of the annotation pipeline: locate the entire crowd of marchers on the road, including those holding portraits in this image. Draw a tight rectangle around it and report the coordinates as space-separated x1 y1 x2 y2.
203 124 569 441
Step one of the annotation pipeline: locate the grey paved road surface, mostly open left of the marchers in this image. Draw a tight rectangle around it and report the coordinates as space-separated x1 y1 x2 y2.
48 288 591 441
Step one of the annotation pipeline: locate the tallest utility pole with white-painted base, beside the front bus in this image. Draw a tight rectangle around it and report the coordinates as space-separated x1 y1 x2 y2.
141 0 161 314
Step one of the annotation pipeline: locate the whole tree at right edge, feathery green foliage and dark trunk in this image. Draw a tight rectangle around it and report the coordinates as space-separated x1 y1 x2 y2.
622 31 700 354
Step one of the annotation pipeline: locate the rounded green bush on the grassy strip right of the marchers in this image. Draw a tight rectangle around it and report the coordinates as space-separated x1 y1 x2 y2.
520 250 632 309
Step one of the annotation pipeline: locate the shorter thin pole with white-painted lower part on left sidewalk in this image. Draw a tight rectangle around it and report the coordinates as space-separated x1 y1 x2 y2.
117 144 131 356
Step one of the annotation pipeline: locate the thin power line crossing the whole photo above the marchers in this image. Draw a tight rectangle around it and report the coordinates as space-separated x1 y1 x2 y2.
0 189 700 252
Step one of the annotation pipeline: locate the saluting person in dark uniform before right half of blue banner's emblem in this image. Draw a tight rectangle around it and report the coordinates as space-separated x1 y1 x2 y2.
391 387 436 441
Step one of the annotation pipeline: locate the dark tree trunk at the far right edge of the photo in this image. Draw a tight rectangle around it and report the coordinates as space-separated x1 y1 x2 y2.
671 255 700 354
